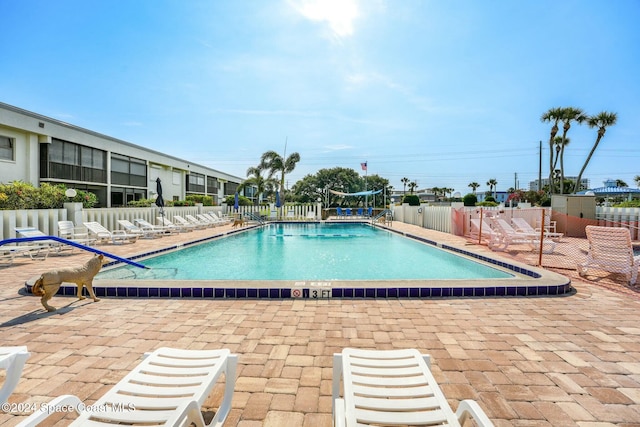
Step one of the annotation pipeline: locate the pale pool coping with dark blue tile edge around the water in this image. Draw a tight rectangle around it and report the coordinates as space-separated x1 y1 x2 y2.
25 220 574 299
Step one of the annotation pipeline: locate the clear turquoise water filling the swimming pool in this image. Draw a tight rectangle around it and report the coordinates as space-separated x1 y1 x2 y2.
97 223 513 280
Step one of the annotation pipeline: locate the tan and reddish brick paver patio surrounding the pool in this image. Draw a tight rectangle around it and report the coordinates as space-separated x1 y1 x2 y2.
0 223 640 427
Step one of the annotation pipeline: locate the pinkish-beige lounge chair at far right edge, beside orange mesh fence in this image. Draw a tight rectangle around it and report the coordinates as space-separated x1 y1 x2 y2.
578 225 640 285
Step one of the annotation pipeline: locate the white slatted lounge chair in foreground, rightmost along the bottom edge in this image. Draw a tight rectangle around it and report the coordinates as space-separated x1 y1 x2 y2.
332 348 493 427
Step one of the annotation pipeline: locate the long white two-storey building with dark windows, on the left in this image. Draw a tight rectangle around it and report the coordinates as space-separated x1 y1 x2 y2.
0 102 244 207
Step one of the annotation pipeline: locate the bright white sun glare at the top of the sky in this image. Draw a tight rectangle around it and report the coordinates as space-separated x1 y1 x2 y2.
289 0 359 38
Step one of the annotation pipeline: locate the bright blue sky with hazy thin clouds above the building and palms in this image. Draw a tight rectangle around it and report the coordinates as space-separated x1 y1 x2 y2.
0 0 640 194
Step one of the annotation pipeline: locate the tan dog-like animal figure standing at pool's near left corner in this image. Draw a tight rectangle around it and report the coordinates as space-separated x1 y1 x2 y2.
31 255 104 311
